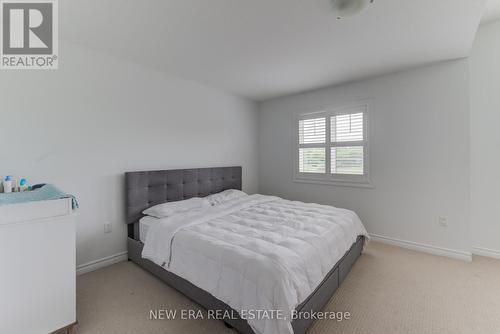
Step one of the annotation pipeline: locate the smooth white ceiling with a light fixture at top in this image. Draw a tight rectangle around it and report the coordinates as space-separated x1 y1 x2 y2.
60 0 488 100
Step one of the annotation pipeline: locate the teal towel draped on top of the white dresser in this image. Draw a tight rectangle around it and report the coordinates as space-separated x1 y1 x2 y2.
0 184 78 210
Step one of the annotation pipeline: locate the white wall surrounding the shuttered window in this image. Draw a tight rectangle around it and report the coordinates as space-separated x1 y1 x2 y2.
259 60 470 257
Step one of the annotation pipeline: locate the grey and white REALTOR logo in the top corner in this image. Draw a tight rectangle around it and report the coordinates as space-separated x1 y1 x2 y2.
0 0 58 69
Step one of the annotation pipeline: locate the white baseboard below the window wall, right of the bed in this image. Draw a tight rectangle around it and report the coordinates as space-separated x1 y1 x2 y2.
370 234 472 262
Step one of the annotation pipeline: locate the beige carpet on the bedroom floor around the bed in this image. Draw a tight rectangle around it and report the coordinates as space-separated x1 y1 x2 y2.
73 242 500 334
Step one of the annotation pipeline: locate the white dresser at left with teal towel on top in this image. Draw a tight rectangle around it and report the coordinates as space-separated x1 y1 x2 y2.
0 199 76 334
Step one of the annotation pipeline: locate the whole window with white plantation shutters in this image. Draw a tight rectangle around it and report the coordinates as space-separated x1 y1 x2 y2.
295 104 369 185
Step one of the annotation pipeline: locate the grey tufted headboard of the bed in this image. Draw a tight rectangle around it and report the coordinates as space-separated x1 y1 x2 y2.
125 167 241 235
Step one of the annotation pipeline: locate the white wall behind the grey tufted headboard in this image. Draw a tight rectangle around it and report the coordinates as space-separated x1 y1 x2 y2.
0 43 258 264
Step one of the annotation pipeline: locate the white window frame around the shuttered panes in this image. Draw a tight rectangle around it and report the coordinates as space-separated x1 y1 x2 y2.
293 101 372 188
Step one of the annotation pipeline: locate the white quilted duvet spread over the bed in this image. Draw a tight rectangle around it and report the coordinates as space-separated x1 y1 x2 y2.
142 195 368 334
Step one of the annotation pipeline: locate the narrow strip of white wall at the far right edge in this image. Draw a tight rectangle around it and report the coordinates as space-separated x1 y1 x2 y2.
470 21 500 257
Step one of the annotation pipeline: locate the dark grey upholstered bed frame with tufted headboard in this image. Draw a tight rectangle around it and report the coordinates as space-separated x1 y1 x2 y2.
125 167 364 334
